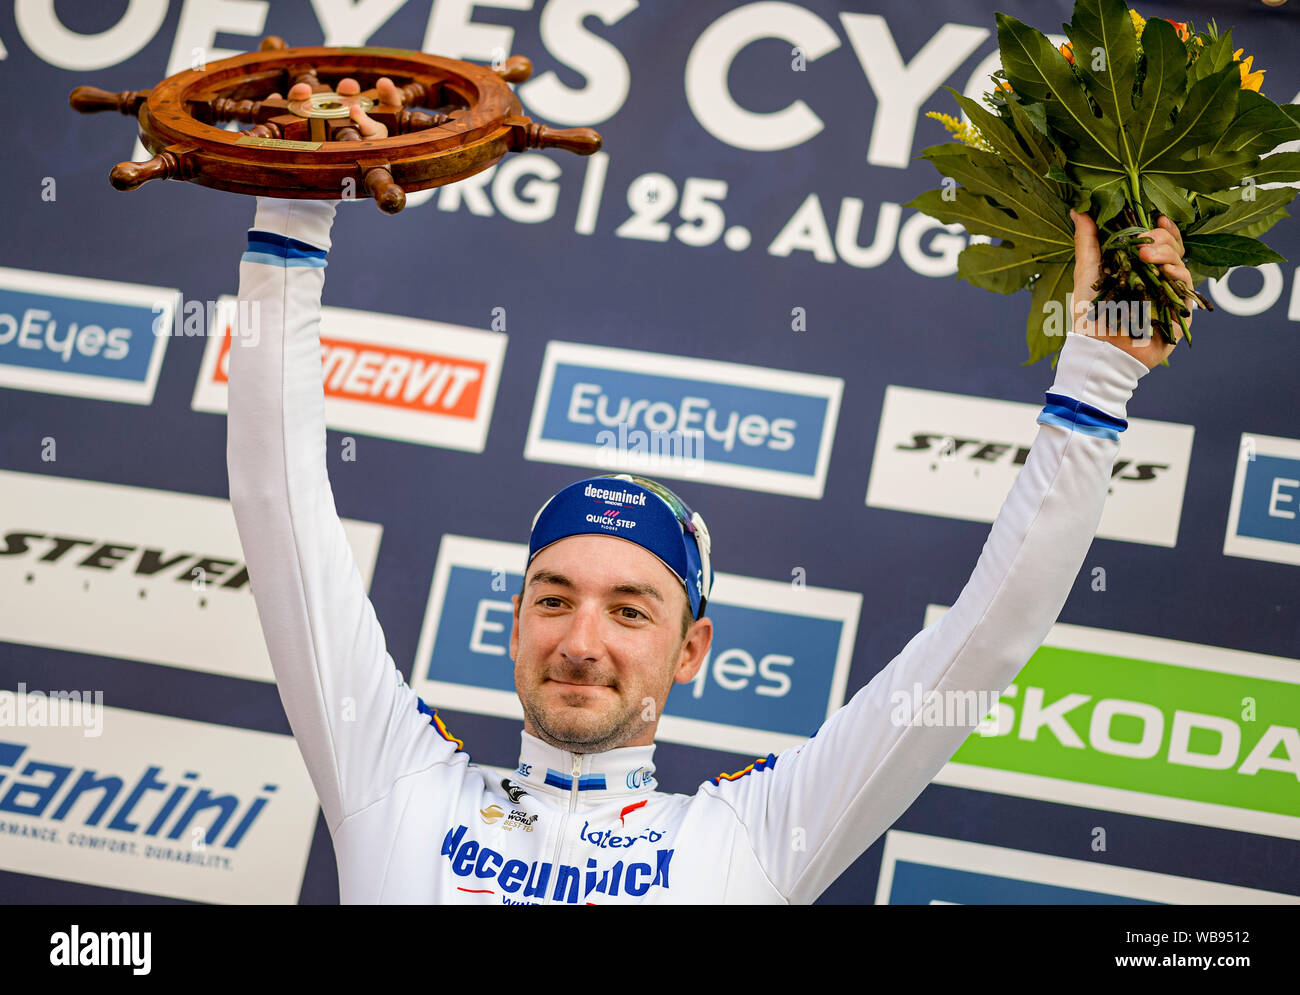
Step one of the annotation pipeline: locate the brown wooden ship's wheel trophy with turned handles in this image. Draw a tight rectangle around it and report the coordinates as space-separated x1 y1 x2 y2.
69 38 601 215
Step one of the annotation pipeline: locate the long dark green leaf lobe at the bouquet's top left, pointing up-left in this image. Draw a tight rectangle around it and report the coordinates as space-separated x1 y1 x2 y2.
997 14 1121 164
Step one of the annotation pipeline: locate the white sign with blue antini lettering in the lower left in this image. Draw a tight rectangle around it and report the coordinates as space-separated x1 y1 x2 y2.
0 708 317 903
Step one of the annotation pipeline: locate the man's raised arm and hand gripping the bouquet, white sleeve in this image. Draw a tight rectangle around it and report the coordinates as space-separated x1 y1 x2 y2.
702 208 1192 903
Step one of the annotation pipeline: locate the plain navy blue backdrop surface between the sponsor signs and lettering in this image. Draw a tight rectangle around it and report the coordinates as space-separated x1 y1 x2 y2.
0 0 1300 903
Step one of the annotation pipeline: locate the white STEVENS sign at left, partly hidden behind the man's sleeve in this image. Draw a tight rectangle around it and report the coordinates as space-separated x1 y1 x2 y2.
0 471 382 680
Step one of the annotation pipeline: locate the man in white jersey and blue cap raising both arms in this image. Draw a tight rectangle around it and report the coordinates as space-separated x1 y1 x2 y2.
229 81 1191 904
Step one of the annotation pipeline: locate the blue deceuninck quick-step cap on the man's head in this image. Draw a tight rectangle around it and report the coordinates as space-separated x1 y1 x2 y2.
525 473 714 619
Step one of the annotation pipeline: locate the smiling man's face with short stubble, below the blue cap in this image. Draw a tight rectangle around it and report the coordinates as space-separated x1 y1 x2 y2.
510 535 714 753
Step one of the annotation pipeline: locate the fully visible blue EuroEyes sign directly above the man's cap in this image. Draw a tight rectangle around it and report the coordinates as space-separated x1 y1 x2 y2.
524 342 844 498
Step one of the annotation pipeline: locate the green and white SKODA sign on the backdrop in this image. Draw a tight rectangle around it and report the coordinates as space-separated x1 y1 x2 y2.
926 605 1300 839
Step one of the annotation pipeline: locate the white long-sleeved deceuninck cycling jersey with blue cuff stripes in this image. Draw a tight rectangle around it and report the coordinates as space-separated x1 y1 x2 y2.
229 199 1147 905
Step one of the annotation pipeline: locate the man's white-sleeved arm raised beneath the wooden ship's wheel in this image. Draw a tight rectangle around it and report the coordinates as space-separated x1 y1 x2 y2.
226 198 464 832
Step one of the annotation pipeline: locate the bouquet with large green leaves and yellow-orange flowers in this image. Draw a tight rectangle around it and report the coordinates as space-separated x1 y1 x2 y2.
907 0 1300 365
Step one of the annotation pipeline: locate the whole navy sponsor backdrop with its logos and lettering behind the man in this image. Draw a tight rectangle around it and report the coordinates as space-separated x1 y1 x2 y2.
0 0 1300 903
